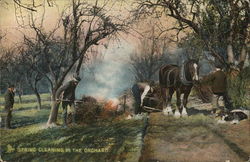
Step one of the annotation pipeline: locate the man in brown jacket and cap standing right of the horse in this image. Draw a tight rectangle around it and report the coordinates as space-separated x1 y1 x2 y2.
202 65 232 111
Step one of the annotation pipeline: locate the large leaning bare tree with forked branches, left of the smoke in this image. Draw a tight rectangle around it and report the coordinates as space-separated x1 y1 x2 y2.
23 0 128 125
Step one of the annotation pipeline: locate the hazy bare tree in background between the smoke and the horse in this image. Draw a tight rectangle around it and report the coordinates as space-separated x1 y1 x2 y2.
130 25 166 81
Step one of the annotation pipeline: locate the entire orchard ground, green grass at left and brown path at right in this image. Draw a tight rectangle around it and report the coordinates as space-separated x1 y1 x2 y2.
0 94 250 162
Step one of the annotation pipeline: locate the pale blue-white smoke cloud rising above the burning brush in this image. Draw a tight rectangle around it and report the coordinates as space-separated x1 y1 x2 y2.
76 41 134 99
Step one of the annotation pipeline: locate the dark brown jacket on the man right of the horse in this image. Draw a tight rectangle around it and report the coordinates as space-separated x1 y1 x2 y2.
202 70 227 93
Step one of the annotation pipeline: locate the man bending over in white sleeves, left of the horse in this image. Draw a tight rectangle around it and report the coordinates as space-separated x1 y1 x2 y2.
132 82 153 114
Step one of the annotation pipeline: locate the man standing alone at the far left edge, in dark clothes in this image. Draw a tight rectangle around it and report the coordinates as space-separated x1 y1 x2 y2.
4 85 15 129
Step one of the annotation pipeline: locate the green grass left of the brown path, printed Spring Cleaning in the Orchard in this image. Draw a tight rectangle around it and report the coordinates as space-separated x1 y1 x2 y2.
0 94 145 162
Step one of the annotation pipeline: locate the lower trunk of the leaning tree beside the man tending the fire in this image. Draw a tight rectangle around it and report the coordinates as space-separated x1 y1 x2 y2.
47 91 60 125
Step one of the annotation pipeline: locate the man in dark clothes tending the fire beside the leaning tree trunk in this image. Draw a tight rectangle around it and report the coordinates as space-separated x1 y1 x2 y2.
56 76 81 127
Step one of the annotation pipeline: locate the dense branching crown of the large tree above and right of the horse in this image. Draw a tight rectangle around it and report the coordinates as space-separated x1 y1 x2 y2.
135 0 250 70
